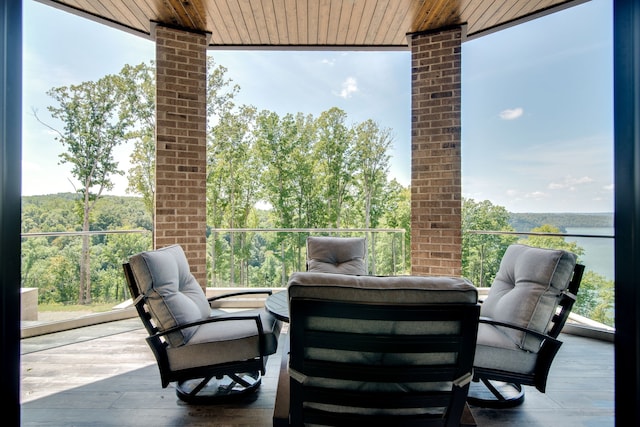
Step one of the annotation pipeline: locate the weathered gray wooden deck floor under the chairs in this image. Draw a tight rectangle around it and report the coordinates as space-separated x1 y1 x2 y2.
21 319 615 427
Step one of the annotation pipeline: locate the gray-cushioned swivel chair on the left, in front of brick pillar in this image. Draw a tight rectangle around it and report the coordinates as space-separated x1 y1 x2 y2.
123 245 281 403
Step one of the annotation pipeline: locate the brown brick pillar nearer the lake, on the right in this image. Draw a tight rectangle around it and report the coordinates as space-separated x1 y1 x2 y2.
410 27 464 276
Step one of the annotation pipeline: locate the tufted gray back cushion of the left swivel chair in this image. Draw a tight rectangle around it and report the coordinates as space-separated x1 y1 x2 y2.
129 245 211 347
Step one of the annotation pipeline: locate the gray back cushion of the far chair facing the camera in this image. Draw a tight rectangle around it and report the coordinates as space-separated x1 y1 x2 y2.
307 236 367 275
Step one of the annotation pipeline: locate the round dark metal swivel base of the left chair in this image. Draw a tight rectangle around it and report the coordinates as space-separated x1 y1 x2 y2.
176 371 262 405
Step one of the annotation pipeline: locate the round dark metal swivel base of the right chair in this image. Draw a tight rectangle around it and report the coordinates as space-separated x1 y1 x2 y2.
467 378 524 409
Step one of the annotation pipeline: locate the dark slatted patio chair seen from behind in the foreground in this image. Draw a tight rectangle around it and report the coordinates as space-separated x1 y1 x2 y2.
273 272 480 427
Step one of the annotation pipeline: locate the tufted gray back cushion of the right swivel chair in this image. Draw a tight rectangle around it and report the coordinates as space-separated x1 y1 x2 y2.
478 245 576 352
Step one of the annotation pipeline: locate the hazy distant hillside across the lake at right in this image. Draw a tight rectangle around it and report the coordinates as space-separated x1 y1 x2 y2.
509 213 613 232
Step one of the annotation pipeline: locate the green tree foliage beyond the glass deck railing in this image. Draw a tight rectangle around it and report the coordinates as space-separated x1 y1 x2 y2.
22 61 613 323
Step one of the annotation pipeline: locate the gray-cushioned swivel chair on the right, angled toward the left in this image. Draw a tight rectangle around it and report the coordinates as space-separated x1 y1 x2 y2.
467 245 584 408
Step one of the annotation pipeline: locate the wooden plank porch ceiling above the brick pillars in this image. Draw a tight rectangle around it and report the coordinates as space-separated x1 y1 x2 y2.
39 0 584 49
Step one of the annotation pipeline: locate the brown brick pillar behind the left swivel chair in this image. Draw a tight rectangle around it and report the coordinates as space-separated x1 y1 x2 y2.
154 25 207 288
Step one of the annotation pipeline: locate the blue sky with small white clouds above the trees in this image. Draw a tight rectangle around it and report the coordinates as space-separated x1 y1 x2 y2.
22 0 613 212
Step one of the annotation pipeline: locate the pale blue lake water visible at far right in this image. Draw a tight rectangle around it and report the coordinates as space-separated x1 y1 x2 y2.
565 227 614 280
